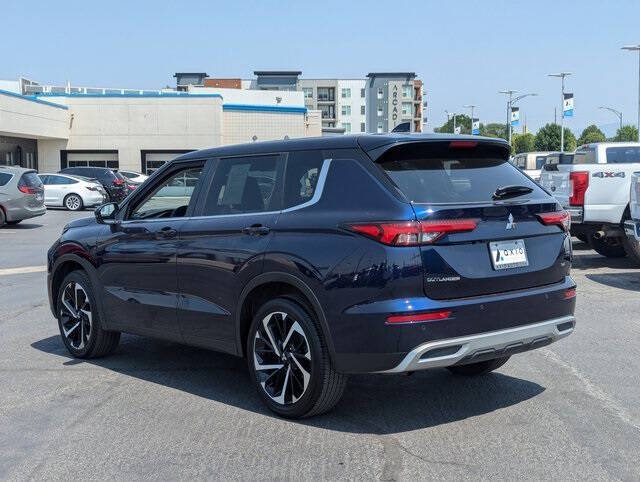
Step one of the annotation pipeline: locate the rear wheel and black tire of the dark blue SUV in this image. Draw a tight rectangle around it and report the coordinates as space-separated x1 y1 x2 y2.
247 298 347 418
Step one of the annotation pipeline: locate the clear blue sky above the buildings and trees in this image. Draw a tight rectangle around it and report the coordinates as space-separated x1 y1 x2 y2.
5 0 640 136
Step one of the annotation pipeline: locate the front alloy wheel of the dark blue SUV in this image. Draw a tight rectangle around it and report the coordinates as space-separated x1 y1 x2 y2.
60 281 93 350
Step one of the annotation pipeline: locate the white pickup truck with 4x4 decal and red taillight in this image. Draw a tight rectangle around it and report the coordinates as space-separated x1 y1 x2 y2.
540 142 640 264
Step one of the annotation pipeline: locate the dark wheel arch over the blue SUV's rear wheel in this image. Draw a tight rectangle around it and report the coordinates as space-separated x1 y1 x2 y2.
236 272 334 361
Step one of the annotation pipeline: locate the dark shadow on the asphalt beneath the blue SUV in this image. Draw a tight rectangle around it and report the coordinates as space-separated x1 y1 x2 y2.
31 335 545 435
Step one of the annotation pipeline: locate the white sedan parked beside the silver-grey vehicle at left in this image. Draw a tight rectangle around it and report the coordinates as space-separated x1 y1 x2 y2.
38 173 109 211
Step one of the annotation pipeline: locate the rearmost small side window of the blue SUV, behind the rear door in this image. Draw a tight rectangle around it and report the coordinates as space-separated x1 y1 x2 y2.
283 151 323 209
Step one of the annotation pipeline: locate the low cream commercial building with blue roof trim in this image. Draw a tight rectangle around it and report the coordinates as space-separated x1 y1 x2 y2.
0 78 321 173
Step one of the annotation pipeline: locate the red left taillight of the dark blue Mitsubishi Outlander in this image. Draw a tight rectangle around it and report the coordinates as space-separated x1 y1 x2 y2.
347 219 478 246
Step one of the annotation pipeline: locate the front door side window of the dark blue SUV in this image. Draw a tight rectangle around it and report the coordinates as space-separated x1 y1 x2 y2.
129 166 203 220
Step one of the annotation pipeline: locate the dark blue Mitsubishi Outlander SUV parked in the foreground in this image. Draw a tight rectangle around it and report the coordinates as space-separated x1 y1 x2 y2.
48 134 576 417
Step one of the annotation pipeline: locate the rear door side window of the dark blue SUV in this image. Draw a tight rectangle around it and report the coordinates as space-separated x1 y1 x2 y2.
203 154 281 216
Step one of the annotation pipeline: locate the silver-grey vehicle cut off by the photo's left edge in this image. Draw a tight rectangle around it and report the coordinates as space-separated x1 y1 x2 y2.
0 166 47 227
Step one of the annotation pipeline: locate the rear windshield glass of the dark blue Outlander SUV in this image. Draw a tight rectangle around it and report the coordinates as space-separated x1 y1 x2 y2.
379 142 544 204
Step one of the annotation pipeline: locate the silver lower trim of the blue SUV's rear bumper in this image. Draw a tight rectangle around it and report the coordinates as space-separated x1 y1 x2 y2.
378 316 576 373
